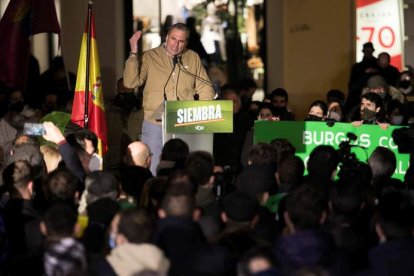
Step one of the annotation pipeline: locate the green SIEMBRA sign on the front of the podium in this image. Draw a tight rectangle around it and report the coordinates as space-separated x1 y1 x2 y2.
165 101 233 133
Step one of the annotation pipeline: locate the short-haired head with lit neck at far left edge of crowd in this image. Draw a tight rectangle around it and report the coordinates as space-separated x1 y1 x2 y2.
3 160 34 199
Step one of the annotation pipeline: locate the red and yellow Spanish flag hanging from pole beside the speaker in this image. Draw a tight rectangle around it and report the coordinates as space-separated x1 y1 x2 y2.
71 10 107 157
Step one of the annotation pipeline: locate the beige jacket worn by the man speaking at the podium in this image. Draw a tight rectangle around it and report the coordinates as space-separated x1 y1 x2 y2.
124 46 214 123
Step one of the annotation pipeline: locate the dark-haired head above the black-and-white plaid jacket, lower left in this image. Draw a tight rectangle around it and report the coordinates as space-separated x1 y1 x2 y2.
40 202 78 240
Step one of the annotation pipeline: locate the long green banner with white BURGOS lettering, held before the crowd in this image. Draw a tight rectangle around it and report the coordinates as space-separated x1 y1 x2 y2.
254 121 410 179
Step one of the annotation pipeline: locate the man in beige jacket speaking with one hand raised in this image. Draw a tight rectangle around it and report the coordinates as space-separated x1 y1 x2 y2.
124 23 214 175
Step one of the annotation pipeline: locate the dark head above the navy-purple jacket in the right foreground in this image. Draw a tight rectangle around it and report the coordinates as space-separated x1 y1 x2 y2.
284 184 328 233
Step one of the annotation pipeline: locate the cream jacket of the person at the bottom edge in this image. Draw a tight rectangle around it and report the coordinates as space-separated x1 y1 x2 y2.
106 243 170 276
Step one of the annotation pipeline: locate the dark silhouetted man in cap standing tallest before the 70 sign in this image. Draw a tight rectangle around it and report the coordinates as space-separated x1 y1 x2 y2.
346 42 378 110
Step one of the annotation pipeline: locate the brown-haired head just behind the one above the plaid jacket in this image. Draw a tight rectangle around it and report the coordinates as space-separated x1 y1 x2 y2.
43 168 79 204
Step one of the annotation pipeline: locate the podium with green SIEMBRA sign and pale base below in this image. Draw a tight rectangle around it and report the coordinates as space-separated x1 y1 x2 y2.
162 100 233 154
